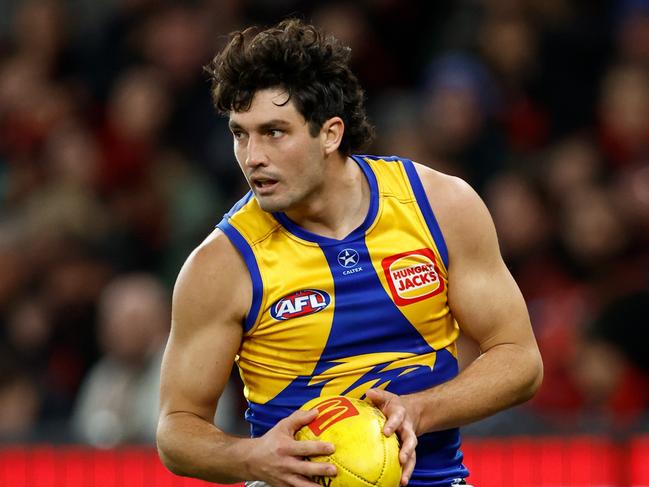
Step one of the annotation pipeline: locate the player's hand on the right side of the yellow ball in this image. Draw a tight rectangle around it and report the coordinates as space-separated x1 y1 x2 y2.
366 389 417 486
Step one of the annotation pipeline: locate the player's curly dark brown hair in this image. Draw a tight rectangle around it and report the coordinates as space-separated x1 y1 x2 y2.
206 19 374 155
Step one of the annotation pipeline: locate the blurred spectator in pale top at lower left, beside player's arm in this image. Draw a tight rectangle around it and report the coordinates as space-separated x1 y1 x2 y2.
72 274 170 446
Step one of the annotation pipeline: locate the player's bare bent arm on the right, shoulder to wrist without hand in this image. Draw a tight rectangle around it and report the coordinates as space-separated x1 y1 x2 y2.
409 166 543 434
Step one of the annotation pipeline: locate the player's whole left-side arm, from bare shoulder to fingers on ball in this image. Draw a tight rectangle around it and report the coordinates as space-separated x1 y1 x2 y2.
157 230 335 487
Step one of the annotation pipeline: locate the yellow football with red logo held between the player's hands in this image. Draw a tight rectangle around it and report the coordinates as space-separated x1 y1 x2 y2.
295 396 401 487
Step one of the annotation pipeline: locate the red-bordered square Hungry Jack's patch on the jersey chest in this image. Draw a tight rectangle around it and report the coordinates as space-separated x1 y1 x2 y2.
381 249 444 306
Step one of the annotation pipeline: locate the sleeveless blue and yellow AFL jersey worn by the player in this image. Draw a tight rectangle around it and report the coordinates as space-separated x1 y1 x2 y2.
218 156 468 485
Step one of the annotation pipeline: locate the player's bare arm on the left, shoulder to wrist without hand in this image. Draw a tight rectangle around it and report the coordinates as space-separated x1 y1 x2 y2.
157 231 250 482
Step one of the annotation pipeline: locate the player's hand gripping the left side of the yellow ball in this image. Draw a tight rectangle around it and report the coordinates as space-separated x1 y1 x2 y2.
242 409 336 487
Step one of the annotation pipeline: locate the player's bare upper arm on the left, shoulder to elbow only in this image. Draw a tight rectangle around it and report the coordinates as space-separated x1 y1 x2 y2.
160 230 251 422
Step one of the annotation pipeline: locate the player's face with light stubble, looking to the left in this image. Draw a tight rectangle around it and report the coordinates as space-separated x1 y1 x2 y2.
230 89 325 212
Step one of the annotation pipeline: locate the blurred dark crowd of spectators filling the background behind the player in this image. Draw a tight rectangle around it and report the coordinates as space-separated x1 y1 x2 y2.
0 0 649 446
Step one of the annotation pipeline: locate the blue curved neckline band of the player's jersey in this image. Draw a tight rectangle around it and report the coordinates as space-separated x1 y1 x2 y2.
273 155 379 245
